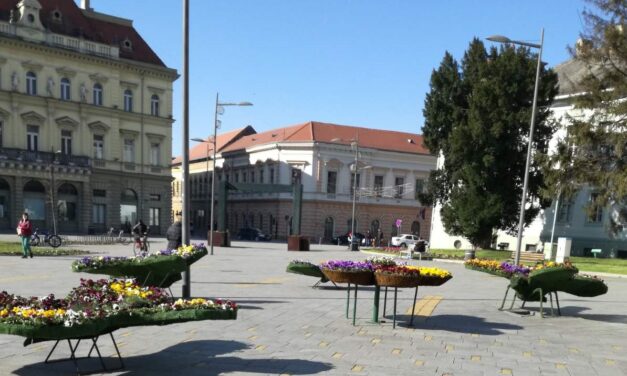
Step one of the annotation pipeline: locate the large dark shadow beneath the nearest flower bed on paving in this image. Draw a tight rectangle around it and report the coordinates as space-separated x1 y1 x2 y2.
14 340 333 376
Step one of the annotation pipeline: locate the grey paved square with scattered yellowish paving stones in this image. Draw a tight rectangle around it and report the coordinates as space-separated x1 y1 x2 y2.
0 239 627 376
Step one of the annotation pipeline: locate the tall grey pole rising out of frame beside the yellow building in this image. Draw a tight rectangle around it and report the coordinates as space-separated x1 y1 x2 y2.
182 0 191 298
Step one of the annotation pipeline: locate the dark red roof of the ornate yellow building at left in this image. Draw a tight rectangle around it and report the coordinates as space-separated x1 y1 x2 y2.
0 0 165 67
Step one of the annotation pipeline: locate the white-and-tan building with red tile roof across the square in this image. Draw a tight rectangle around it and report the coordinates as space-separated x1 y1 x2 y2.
173 122 436 242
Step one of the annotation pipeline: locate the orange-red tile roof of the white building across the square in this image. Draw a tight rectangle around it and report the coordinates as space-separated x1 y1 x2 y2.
220 121 430 154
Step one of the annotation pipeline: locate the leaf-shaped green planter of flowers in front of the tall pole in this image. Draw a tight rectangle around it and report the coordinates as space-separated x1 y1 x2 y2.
72 244 207 287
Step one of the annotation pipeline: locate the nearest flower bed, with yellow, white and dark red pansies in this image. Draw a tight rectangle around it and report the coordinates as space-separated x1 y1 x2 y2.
0 279 237 341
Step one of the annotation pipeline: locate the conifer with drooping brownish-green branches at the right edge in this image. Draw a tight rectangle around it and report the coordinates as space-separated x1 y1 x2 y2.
546 0 627 233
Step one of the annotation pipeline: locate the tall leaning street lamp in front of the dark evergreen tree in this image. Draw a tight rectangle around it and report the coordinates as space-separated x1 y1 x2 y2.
486 28 544 265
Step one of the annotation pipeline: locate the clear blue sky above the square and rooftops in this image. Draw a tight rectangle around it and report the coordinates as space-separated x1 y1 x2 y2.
87 0 586 155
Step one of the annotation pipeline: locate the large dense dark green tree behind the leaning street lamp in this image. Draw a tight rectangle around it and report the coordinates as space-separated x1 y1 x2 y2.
422 39 557 247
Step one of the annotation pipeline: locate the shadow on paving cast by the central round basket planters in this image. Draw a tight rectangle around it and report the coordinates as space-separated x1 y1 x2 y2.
402 315 523 336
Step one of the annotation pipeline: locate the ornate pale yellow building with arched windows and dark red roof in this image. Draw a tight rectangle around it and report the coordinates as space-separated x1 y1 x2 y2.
0 0 177 233
